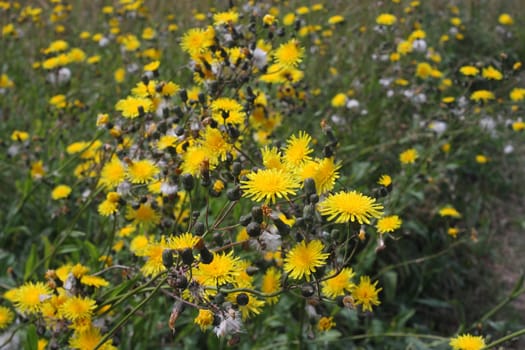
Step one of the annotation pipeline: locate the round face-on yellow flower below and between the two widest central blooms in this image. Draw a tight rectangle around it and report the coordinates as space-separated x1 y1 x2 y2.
284 240 330 281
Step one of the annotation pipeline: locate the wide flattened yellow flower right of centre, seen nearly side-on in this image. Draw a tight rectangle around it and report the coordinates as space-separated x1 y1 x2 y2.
318 191 383 224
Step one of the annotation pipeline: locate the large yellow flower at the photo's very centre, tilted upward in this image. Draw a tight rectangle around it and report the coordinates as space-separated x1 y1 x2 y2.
241 169 299 203
